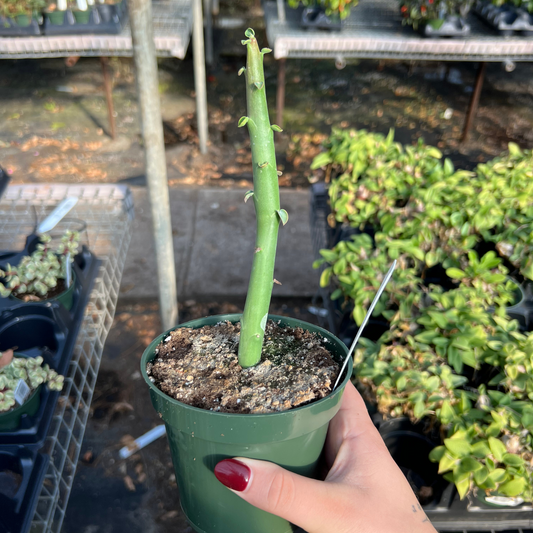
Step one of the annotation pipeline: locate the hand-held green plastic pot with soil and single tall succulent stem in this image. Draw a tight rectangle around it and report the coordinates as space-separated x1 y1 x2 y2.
141 29 351 533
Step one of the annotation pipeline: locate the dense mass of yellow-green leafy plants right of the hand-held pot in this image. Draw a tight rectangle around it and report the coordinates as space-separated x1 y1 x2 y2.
313 130 533 501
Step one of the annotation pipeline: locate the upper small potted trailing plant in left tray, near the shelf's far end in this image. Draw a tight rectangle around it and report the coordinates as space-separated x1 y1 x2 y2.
0 231 79 309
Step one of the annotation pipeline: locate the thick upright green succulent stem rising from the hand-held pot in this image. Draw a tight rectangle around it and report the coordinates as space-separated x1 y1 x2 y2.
239 29 280 368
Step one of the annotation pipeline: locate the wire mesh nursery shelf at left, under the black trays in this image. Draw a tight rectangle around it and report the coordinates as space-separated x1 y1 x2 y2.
0 185 133 533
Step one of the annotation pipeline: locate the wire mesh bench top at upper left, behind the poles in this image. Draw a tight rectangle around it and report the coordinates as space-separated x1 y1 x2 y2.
0 0 193 59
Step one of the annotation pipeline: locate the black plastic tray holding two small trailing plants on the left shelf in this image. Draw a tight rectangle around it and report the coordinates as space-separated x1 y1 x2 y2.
0 236 100 449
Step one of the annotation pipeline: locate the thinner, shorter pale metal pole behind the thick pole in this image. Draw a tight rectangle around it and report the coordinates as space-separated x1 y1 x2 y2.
192 0 207 154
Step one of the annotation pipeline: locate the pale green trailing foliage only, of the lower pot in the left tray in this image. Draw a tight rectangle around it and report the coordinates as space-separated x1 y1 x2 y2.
0 353 64 413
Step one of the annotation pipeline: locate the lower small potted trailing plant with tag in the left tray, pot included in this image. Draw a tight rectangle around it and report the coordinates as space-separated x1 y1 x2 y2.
0 350 64 432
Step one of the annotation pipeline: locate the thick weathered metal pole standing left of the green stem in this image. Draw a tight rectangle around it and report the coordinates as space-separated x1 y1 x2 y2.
128 0 178 330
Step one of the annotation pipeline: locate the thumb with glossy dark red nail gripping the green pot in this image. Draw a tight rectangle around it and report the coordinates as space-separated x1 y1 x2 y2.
215 457 345 533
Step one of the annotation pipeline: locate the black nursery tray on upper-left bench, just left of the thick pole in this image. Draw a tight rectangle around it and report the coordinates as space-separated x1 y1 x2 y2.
43 0 128 35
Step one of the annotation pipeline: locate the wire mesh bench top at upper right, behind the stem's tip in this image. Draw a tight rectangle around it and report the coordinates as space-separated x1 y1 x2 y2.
264 0 533 61
